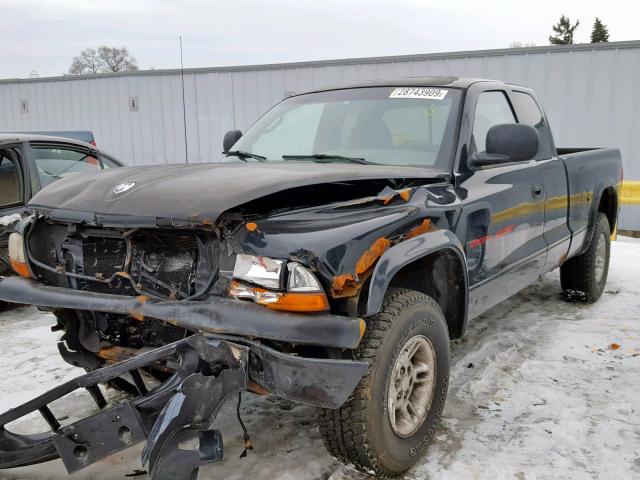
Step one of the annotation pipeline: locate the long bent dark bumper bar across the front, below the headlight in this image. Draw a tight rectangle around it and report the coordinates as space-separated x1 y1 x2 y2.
0 277 365 348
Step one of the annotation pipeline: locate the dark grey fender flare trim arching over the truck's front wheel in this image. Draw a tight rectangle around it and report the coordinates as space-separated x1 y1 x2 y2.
366 230 469 318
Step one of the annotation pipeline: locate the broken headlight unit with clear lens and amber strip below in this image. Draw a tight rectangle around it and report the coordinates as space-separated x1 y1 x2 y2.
229 255 329 312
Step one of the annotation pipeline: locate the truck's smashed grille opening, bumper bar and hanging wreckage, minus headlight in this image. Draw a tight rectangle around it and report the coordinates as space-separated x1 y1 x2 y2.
0 209 376 480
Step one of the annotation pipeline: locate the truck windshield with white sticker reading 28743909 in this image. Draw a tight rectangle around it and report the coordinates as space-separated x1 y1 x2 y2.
226 87 461 170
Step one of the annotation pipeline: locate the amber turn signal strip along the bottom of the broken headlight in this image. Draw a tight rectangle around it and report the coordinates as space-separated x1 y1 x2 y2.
229 280 329 312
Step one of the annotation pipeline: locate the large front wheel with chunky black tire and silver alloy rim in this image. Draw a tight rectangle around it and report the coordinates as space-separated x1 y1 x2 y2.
318 288 449 478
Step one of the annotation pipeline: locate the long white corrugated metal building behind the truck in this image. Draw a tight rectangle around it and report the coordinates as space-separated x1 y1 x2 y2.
0 41 640 230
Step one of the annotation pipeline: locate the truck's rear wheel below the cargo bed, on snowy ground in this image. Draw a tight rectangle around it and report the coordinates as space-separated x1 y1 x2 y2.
560 212 611 303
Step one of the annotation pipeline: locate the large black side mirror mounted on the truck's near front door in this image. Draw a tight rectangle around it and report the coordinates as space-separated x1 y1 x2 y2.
471 123 540 166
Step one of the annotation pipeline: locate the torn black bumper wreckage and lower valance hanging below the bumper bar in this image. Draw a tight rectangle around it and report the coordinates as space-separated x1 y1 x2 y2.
0 334 367 480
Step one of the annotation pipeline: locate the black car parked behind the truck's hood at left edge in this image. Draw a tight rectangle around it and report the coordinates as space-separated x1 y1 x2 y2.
0 132 124 275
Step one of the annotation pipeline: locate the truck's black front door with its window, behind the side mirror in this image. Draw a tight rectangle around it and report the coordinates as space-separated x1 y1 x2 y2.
461 90 546 316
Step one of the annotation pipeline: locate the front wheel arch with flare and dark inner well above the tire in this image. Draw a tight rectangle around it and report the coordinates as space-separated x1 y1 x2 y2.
365 230 468 339
